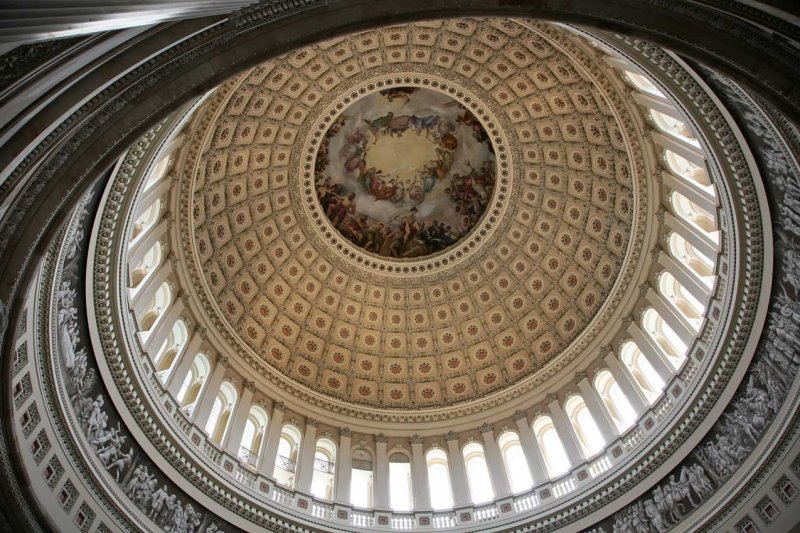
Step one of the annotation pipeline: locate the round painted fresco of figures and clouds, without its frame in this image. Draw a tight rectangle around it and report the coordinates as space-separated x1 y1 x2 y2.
314 86 495 259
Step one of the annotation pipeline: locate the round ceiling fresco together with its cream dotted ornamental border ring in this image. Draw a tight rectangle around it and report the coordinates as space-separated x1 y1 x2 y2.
301 73 513 276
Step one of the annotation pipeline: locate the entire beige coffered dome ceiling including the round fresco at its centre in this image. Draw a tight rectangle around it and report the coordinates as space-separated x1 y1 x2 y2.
176 16 646 408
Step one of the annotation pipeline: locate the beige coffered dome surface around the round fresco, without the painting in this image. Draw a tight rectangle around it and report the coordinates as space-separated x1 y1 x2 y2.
177 20 643 408
